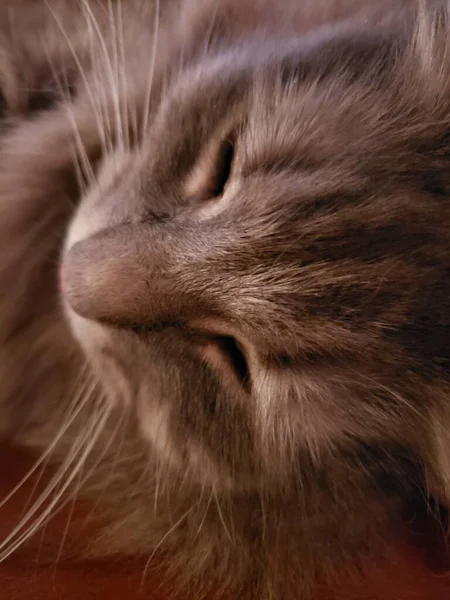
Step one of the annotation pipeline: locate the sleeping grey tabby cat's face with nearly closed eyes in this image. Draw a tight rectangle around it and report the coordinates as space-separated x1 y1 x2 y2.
62 18 449 489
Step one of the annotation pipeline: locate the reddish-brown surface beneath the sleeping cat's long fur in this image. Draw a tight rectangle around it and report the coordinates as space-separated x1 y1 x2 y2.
0 448 450 600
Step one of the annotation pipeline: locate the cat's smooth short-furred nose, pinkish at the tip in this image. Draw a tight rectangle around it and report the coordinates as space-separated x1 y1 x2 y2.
61 225 206 327
